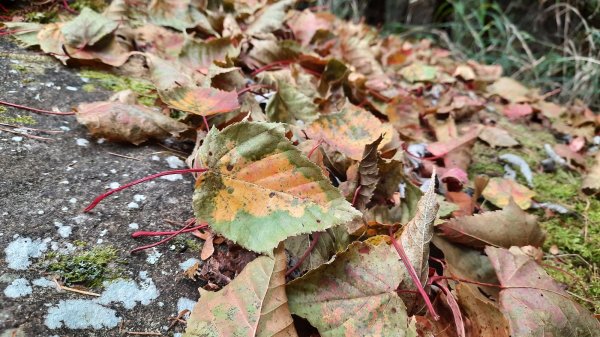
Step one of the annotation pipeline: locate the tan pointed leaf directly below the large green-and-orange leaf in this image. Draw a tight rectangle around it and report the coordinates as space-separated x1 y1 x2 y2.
184 246 298 337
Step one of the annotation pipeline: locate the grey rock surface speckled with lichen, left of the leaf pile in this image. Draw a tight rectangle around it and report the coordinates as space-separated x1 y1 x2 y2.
0 40 204 337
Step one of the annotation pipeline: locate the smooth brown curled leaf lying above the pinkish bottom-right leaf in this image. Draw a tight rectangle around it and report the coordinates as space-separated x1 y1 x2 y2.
438 200 545 248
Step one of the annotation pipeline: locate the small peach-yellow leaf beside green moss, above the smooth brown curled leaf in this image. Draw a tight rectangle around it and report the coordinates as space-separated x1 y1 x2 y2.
483 177 535 209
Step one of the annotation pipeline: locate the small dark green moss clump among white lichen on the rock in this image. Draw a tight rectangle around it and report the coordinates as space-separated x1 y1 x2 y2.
45 246 122 287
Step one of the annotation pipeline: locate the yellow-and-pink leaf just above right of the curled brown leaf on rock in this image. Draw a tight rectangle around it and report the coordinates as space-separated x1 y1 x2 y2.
158 87 240 116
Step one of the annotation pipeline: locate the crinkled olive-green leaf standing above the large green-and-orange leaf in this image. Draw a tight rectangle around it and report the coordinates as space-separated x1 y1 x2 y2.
266 81 318 124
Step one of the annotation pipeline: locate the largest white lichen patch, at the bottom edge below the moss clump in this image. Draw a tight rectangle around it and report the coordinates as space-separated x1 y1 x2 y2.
45 300 121 329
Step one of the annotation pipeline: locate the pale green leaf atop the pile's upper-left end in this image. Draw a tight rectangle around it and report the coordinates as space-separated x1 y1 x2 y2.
60 7 119 49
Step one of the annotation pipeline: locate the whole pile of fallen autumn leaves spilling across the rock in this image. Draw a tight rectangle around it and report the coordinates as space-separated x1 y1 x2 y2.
4 0 600 337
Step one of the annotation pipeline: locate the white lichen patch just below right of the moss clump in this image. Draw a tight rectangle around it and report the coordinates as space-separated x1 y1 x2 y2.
97 272 159 309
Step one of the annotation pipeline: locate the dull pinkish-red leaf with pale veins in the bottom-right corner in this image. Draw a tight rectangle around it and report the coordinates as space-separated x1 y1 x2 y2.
485 247 600 337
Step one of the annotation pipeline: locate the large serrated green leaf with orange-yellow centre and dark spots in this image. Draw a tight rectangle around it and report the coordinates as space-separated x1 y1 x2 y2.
194 122 360 253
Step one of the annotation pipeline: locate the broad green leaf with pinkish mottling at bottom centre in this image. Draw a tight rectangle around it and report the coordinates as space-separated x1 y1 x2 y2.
287 238 416 337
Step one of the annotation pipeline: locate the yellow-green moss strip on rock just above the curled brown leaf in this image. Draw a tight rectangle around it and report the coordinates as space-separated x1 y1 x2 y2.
80 70 158 106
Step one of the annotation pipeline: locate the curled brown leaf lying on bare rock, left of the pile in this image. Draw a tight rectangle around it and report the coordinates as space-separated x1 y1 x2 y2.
76 102 188 145
